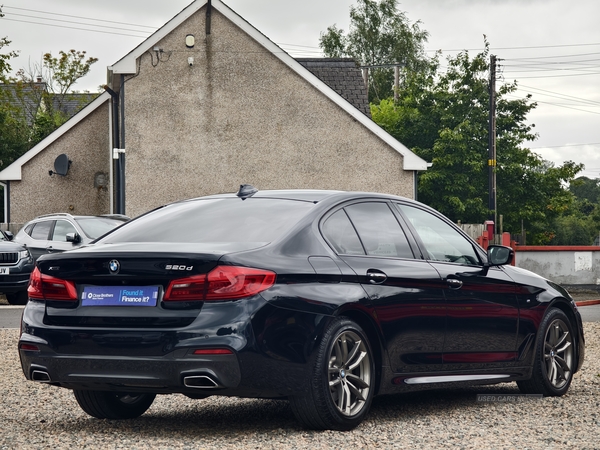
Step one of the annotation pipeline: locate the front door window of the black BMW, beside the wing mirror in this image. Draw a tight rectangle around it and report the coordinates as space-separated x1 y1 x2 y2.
396 204 481 265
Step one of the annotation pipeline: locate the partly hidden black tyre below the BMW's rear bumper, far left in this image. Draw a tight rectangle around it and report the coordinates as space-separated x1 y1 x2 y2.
73 390 156 420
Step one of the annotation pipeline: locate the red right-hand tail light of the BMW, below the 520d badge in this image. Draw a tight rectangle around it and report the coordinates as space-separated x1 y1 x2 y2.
163 266 276 301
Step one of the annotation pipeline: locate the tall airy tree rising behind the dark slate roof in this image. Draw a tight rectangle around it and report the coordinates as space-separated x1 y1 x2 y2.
319 0 428 101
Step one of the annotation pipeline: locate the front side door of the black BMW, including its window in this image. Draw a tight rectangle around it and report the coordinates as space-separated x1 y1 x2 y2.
396 203 519 369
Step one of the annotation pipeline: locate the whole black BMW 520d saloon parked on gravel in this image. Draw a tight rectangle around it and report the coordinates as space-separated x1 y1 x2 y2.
18 185 584 430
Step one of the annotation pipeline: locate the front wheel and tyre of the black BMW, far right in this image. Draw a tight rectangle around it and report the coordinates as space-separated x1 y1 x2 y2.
517 308 576 396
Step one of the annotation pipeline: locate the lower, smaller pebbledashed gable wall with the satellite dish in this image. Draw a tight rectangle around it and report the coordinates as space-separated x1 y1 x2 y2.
10 102 110 223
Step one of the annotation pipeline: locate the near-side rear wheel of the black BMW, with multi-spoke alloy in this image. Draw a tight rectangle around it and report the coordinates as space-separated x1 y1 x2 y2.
290 317 376 431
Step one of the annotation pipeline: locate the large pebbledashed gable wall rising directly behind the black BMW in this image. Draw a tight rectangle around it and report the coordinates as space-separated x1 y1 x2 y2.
125 8 414 216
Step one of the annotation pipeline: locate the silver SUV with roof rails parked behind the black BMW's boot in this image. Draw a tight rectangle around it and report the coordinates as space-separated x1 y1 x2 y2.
15 213 129 260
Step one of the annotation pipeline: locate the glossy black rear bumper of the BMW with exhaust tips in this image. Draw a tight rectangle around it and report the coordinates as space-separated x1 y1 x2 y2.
19 300 328 398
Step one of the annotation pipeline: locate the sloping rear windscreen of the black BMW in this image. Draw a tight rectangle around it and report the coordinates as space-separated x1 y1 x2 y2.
100 198 314 243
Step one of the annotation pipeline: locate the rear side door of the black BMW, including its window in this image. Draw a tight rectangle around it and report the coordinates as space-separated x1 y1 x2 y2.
322 200 446 373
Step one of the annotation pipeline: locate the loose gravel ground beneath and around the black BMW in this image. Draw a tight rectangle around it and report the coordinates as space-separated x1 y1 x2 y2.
0 323 600 450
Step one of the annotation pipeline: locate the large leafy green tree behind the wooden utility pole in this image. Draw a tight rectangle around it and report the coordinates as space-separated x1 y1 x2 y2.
371 42 583 244
